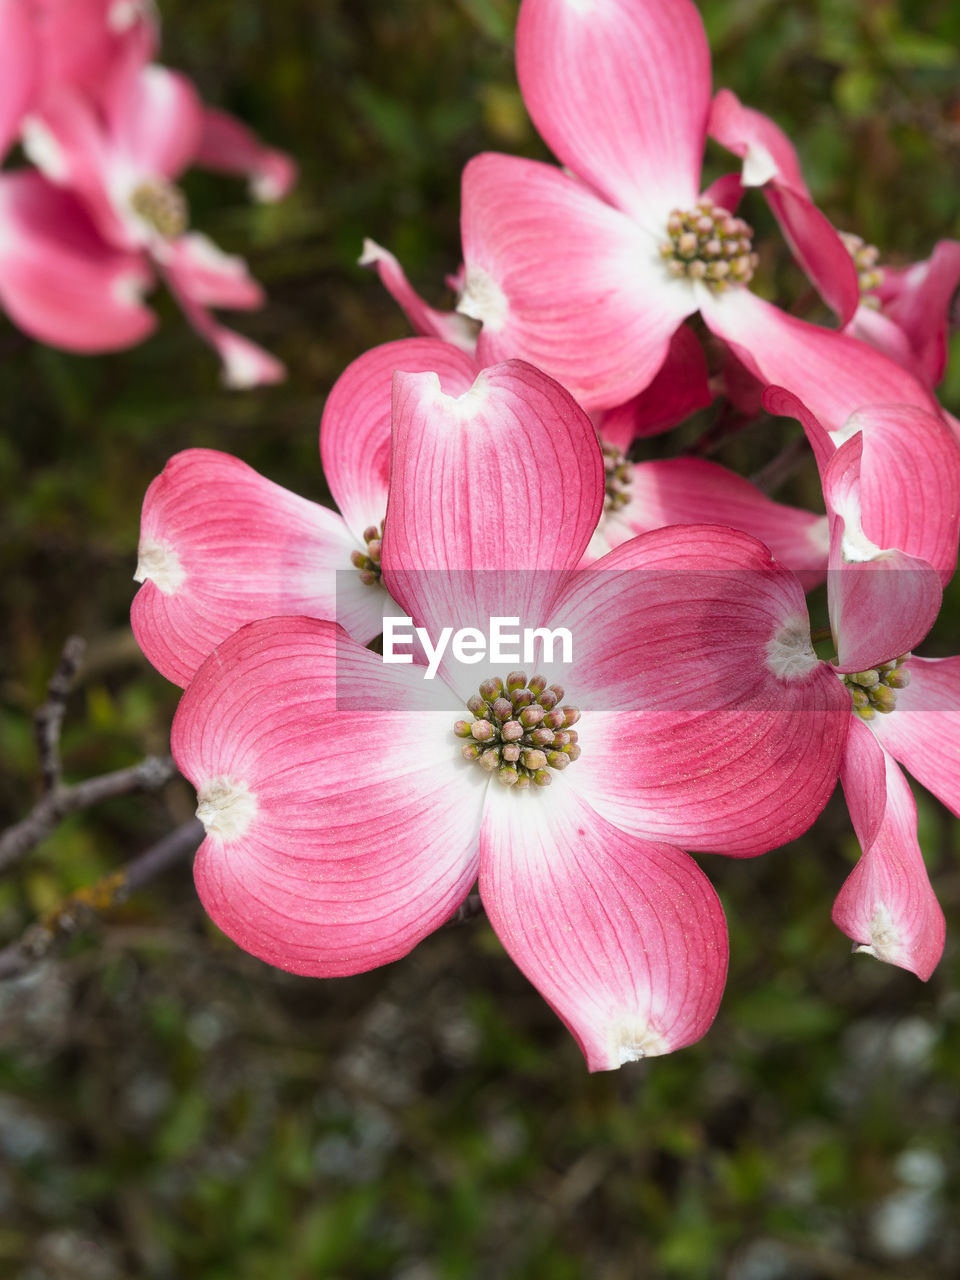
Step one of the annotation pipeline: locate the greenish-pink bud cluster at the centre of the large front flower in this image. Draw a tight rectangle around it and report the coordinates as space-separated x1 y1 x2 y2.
453 671 580 790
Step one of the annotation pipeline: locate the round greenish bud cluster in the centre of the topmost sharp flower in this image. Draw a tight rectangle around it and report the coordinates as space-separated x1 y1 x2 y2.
660 196 759 293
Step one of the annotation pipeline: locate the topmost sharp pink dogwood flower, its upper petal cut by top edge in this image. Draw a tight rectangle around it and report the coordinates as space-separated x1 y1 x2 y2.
460 0 947 410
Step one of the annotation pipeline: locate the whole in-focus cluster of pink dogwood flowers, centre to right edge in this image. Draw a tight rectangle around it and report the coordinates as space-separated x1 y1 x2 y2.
133 0 960 1070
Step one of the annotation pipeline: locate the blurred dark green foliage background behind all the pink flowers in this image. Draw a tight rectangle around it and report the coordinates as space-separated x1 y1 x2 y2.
0 0 960 1280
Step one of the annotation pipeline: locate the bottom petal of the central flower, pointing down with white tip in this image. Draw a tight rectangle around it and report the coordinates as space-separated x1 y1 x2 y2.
480 780 728 1071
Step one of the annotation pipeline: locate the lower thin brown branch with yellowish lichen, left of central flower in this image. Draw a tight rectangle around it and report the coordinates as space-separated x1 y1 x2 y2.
0 814 204 980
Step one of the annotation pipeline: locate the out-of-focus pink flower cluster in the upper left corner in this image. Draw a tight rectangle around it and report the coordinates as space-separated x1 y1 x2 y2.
0 0 296 387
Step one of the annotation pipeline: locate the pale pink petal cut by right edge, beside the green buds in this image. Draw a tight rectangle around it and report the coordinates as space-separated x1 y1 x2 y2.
870 658 960 817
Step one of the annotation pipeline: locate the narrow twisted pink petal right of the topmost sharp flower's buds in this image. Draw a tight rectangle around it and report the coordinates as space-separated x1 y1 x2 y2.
710 88 860 324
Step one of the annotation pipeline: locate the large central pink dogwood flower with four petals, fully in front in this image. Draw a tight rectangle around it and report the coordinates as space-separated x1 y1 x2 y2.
173 361 849 1070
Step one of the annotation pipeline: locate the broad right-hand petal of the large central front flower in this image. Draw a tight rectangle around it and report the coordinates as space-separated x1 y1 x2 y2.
540 525 850 856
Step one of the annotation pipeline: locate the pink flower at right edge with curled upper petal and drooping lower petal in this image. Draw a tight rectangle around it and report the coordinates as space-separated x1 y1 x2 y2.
765 389 960 979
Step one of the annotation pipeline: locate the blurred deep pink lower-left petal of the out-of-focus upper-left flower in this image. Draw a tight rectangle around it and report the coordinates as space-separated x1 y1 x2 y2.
0 169 156 353
